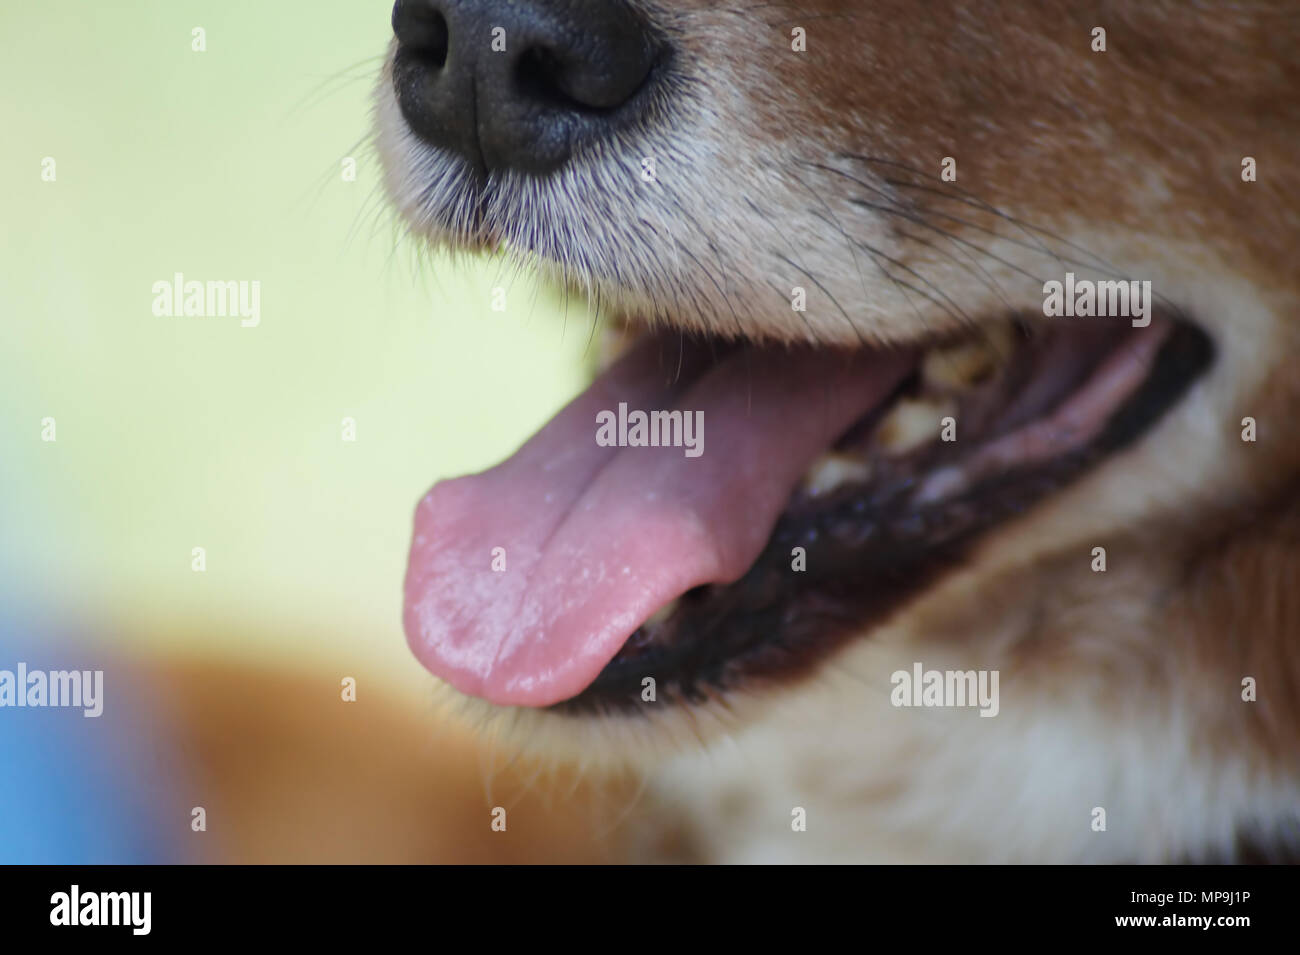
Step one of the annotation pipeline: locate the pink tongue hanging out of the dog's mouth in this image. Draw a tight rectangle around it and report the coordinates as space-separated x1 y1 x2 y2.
404 340 910 707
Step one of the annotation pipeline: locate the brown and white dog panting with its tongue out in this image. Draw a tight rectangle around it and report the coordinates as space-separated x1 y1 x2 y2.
374 0 1300 863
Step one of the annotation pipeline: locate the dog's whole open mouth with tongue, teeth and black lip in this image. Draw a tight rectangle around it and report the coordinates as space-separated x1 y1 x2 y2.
404 309 1213 712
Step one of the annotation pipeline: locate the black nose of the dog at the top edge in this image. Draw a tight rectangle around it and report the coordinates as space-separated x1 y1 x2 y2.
393 0 663 175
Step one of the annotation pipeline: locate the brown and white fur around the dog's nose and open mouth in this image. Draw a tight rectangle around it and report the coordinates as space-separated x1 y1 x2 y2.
377 0 1300 861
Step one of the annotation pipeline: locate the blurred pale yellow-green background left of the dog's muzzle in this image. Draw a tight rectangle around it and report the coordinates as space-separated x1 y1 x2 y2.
0 0 613 859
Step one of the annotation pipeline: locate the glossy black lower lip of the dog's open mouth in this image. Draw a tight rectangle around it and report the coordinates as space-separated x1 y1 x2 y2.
550 313 1214 715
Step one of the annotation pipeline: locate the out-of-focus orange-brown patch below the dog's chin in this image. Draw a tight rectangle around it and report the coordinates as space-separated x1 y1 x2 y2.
140 660 631 864
